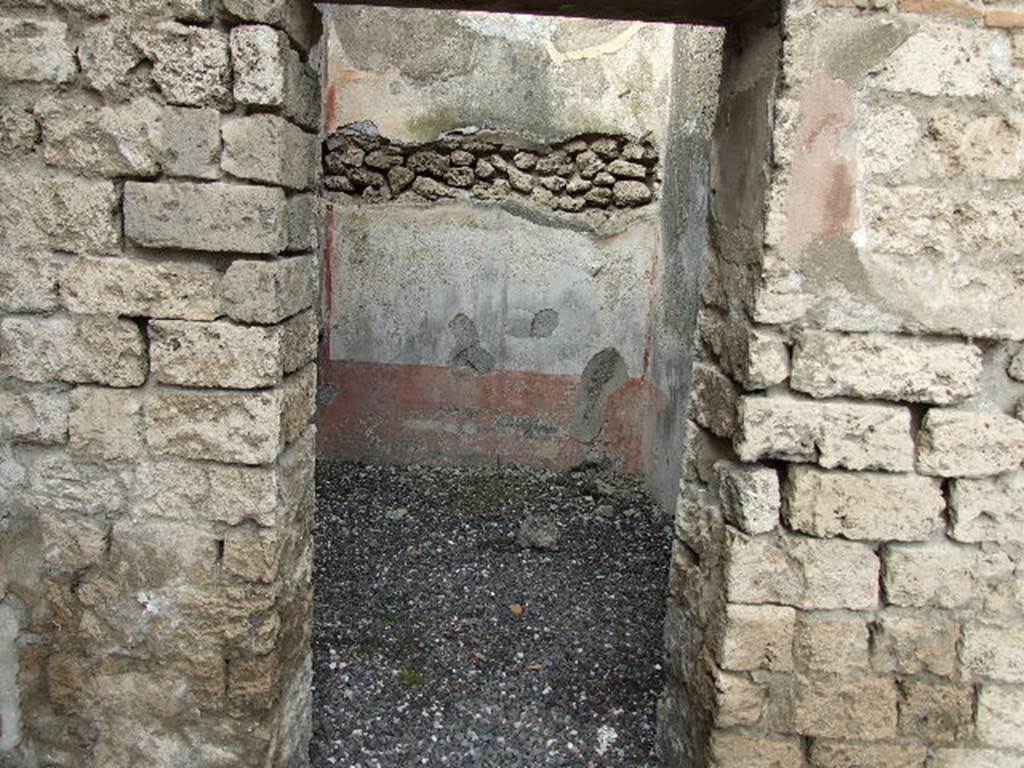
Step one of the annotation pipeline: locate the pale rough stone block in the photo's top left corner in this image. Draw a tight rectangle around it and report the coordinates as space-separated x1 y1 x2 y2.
0 17 78 83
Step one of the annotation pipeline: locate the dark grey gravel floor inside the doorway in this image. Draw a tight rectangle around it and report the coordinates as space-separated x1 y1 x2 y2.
311 461 671 768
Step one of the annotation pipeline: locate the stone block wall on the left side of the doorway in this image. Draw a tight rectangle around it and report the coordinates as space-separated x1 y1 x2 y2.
0 0 321 768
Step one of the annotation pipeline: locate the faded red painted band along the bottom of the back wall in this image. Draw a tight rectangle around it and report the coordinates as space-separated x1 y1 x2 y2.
317 360 650 474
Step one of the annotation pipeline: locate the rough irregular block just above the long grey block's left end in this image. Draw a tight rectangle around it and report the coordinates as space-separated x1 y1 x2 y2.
36 96 161 177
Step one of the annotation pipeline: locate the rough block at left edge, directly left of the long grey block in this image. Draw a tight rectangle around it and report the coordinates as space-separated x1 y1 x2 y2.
0 166 121 253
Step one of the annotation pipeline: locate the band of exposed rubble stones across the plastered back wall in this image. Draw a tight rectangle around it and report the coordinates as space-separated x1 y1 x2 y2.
324 122 659 213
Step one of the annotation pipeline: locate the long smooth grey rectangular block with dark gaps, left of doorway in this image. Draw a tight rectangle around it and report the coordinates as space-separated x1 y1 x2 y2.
124 181 288 254
